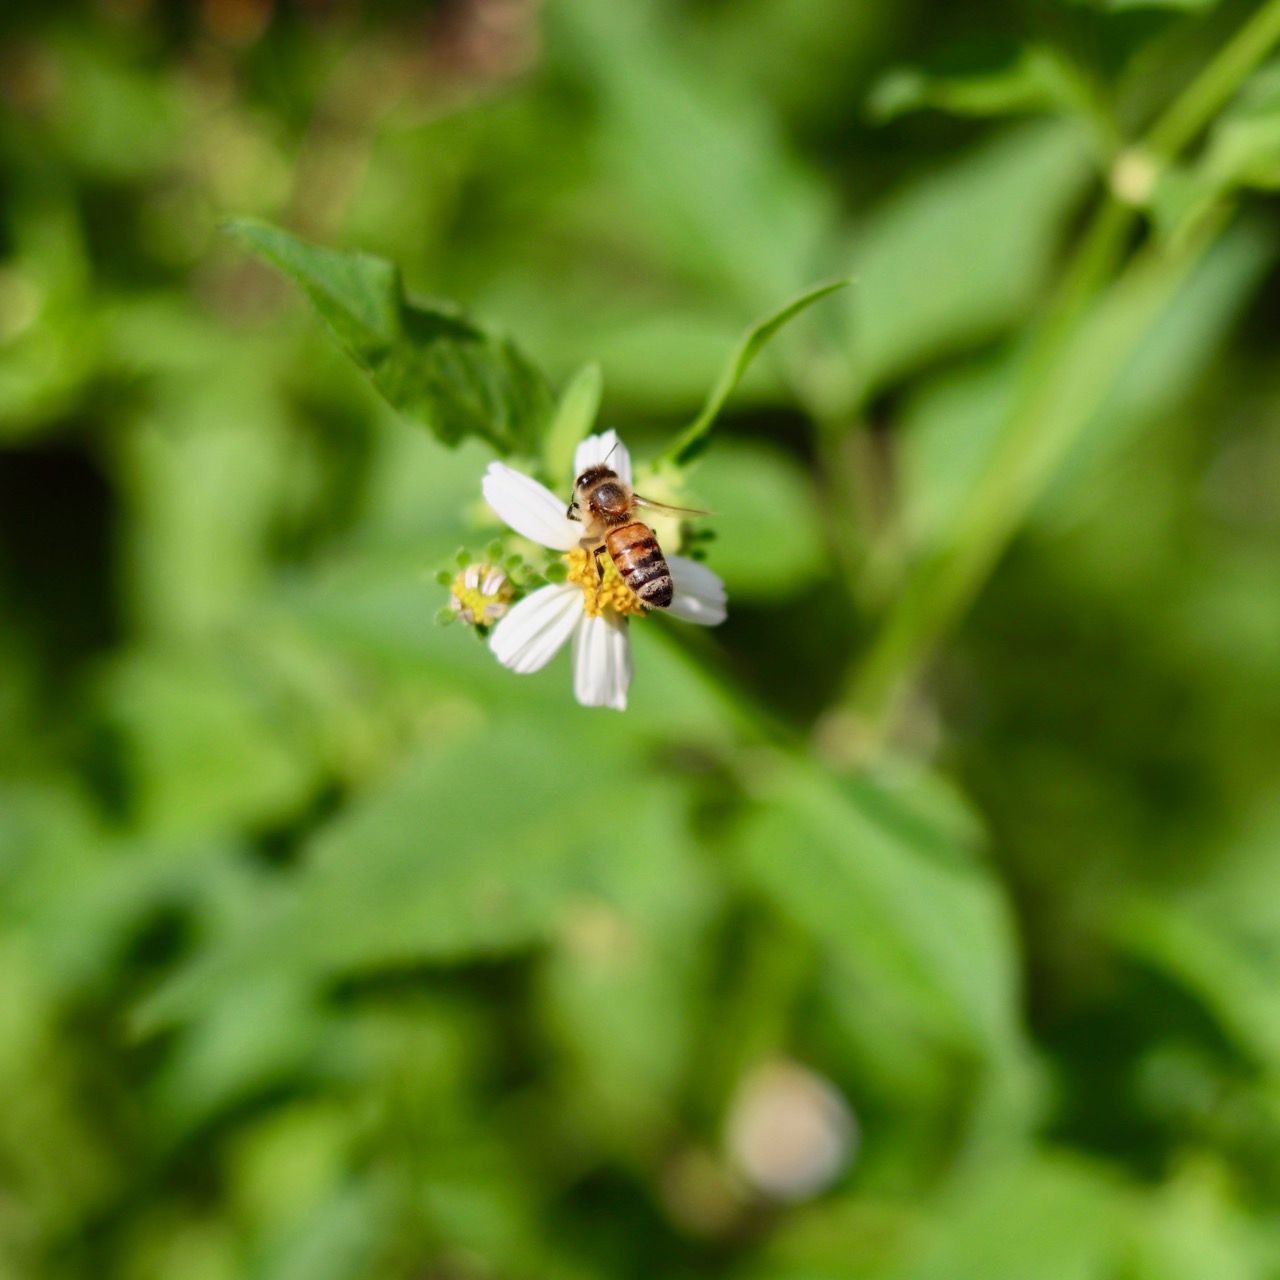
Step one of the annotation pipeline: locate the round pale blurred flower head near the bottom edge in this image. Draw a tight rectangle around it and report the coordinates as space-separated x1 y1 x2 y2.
726 1060 858 1201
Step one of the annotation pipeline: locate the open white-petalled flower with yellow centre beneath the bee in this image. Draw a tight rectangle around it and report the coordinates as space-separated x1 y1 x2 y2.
481 431 724 710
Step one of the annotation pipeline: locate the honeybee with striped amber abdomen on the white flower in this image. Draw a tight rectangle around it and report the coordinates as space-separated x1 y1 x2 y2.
567 462 709 609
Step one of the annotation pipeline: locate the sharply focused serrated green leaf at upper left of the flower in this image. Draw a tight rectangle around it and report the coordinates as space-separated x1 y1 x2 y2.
229 220 552 453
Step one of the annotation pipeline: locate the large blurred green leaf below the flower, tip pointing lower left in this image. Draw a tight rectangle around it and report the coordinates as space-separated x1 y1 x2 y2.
148 727 634 1018
